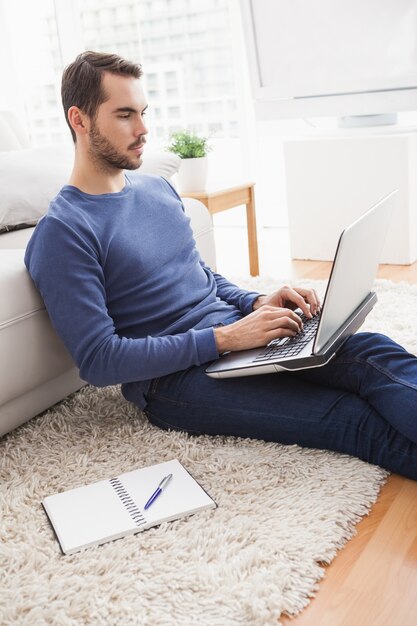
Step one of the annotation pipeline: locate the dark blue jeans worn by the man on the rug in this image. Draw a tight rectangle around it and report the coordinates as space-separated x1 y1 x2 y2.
129 333 417 479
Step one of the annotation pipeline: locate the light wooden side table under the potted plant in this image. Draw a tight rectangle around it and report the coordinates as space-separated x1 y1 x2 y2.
184 183 259 276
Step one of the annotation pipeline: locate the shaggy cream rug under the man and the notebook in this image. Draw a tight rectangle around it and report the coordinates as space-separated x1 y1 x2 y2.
0 279 417 626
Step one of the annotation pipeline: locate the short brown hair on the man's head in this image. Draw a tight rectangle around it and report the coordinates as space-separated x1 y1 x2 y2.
61 50 142 143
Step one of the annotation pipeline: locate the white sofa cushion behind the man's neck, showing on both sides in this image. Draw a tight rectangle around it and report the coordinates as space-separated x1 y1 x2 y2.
0 144 181 233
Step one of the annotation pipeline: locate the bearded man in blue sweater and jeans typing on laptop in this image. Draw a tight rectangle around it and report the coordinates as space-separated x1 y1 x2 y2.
26 52 417 478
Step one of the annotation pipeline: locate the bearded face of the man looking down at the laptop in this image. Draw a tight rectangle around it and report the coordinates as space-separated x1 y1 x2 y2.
88 72 148 171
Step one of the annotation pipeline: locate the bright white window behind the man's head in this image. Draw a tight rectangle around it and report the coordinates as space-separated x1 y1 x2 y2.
0 0 247 144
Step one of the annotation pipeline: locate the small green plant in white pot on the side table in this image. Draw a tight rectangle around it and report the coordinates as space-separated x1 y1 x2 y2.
168 130 211 193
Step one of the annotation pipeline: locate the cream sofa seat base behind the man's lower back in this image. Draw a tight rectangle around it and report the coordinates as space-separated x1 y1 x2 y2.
0 249 84 436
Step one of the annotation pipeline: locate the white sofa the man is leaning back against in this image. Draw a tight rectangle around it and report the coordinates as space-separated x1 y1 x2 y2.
0 112 215 436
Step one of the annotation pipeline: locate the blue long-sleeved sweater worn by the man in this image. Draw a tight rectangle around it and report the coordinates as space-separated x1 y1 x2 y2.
25 174 259 407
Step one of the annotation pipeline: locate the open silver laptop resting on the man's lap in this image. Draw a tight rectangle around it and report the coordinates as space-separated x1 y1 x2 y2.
206 189 398 378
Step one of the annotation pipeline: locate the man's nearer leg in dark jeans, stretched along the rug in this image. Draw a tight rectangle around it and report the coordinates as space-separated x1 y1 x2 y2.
122 342 417 479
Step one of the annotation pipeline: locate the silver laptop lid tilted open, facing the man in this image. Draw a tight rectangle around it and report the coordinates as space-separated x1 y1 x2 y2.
313 189 398 354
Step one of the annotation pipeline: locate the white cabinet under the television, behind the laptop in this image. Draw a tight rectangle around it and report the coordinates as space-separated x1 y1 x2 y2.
284 128 417 264
